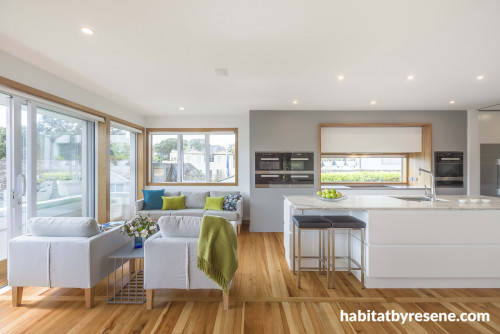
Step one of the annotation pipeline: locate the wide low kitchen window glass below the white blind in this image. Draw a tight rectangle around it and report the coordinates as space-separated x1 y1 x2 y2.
321 154 407 183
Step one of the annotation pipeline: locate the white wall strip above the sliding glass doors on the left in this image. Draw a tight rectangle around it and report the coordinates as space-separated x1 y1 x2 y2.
0 51 144 125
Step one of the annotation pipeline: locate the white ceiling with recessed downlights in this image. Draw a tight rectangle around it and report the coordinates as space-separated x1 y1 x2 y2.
0 0 500 116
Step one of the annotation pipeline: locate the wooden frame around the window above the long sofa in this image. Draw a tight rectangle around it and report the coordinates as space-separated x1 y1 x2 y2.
145 128 239 187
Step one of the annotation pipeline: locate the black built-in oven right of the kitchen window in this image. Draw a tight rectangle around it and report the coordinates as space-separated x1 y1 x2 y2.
434 151 464 188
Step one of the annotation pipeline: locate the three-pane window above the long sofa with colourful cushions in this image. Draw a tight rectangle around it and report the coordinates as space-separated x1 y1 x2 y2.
148 129 238 185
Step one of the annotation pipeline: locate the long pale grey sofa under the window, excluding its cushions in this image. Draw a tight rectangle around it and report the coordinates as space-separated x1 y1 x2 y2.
135 190 243 234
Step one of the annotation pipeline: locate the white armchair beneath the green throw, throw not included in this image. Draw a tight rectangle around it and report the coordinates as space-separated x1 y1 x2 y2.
144 216 237 309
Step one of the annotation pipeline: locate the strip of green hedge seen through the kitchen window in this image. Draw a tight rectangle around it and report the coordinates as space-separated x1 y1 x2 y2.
321 171 402 183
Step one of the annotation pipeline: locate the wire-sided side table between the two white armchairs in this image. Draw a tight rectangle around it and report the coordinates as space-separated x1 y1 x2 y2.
106 242 146 304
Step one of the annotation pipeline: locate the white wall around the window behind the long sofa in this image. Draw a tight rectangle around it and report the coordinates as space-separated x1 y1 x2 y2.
145 115 250 219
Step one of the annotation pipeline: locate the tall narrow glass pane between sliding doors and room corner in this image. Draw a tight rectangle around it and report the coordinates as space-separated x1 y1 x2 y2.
109 127 136 221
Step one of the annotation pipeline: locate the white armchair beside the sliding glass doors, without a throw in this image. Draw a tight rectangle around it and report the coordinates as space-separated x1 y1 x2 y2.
7 217 131 308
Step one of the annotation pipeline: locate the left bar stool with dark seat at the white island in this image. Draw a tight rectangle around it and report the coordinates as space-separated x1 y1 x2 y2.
292 216 332 289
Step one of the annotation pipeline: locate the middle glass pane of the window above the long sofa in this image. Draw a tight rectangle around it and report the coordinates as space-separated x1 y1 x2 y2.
182 135 206 182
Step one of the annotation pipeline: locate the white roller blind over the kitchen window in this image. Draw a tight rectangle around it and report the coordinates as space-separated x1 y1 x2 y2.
321 127 422 153
